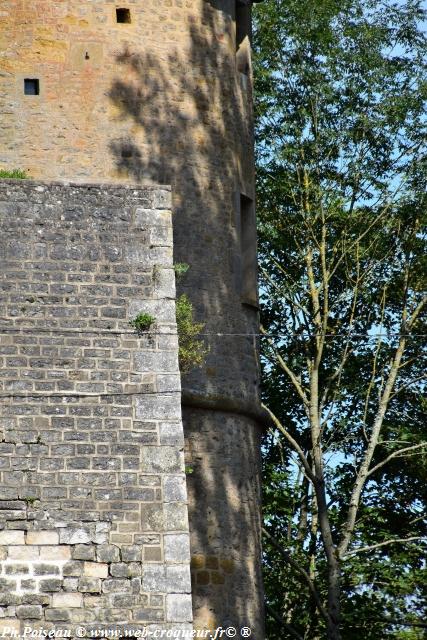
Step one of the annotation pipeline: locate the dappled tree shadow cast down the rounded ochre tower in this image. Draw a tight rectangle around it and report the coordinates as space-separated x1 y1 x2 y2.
109 0 263 639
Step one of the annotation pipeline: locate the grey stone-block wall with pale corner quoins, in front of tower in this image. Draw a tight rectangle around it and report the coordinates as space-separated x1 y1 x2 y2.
0 181 192 631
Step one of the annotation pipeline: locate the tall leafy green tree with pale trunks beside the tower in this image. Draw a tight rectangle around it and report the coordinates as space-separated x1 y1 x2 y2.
255 0 427 640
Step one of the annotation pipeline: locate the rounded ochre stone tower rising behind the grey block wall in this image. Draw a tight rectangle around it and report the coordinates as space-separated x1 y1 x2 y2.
0 0 264 640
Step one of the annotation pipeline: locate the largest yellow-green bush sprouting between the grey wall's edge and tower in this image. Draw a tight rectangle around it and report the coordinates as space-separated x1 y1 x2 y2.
176 294 208 373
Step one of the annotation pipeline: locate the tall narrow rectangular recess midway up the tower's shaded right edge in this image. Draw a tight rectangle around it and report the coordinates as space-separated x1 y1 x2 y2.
240 194 258 306
